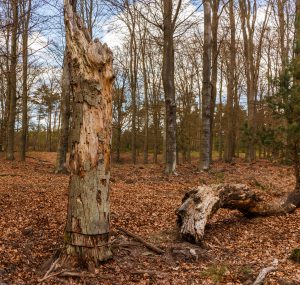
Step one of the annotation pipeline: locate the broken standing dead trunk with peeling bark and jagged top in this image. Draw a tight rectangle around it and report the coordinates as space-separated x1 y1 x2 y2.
64 0 113 267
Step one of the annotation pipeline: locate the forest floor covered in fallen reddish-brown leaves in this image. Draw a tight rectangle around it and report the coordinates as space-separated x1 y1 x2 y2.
0 153 300 285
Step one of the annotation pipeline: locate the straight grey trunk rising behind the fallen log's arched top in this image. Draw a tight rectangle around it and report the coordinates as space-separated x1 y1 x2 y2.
200 0 212 170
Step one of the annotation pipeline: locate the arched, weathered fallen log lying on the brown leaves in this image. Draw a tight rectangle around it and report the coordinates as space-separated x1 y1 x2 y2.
176 184 296 242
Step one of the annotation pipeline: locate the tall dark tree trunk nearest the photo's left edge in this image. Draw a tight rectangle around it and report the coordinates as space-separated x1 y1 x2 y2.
6 0 18 160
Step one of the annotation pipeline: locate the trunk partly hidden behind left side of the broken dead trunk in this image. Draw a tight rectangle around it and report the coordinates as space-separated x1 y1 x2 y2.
55 51 71 173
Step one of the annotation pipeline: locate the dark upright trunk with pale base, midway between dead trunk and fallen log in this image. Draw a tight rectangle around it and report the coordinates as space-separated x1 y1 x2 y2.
162 0 176 174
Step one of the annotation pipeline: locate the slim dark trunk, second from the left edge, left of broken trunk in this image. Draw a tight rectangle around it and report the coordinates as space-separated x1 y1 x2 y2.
20 0 31 161
